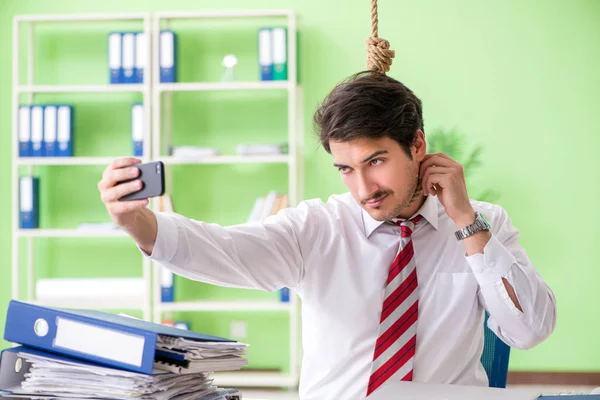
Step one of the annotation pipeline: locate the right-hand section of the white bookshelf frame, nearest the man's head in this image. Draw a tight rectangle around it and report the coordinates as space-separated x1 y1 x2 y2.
152 10 303 388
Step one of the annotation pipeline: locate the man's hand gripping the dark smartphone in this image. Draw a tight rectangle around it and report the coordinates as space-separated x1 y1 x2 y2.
98 157 149 229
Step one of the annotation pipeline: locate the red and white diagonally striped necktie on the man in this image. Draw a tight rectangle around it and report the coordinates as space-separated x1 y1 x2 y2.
367 215 422 396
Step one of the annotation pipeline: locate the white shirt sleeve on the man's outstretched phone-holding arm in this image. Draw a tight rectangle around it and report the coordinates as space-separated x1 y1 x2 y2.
140 203 319 291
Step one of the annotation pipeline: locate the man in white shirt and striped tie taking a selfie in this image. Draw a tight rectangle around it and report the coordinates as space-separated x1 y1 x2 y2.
98 72 556 400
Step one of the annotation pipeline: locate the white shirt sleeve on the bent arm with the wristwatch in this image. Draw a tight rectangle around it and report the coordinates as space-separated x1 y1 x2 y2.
466 207 556 349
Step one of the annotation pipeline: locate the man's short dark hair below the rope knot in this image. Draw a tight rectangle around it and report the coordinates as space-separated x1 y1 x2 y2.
314 71 423 158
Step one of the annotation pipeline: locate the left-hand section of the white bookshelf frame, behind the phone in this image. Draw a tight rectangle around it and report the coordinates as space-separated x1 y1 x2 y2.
11 13 152 320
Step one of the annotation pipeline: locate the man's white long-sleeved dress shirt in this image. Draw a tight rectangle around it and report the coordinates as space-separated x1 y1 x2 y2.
146 193 556 400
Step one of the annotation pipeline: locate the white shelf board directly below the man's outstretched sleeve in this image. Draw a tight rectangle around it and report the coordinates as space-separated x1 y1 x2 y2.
156 300 292 311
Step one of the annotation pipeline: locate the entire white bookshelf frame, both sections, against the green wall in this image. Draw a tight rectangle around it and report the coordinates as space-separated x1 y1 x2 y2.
11 9 303 388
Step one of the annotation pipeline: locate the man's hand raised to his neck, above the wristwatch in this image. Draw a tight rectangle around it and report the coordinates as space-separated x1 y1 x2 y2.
419 153 475 229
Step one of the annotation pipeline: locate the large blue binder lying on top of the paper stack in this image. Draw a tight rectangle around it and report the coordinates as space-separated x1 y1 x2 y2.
4 300 235 375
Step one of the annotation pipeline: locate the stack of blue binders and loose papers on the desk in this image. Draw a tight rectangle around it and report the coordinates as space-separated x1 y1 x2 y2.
0 300 247 400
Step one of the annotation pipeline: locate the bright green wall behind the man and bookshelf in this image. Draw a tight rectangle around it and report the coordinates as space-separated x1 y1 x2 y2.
0 0 600 371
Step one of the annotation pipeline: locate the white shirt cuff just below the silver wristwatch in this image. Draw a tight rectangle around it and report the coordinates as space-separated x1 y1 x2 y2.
465 235 517 285
